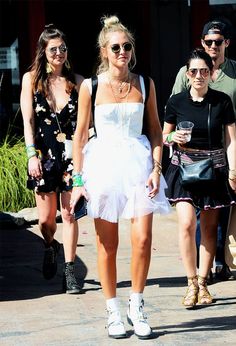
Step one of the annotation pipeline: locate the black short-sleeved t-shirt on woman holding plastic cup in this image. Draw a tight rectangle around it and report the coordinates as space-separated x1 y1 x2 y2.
164 88 235 149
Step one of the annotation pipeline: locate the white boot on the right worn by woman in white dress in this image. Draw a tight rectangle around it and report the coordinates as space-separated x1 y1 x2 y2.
127 299 152 339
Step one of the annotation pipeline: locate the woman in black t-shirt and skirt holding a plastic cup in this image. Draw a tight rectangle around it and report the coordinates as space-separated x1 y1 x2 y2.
163 49 236 307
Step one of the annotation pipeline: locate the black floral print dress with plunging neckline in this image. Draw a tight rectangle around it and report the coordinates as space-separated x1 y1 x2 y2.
28 88 78 192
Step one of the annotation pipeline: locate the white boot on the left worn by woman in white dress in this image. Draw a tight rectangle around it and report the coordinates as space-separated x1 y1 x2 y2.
107 310 127 339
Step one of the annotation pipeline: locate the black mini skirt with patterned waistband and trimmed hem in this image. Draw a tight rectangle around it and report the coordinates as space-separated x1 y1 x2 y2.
165 149 236 210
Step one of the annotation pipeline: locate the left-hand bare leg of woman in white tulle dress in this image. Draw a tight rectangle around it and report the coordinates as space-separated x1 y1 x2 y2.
94 219 119 299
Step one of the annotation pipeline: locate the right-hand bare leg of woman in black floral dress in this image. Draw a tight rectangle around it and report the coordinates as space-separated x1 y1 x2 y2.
61 191 78 262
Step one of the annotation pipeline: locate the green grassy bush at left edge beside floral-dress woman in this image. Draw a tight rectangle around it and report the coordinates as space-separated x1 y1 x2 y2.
0 136 35 212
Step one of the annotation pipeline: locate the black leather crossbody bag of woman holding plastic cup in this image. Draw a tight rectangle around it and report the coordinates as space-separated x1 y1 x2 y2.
178 104 216 188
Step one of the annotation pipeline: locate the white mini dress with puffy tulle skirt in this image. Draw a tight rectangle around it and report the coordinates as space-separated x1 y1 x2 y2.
83 76 170 223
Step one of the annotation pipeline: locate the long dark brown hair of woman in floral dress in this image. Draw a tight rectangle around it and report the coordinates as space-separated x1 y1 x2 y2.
31 24 75 96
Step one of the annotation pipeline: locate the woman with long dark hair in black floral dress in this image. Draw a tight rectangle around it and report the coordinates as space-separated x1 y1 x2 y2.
20 24 83 293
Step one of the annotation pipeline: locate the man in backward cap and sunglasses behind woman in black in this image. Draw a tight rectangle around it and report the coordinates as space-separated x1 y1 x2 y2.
172 20 236 282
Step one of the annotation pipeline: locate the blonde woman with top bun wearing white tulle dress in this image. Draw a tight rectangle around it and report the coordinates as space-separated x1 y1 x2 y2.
71 16 169 339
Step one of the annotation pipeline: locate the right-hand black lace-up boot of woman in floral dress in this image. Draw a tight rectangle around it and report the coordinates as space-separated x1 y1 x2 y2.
63 262 82 294
